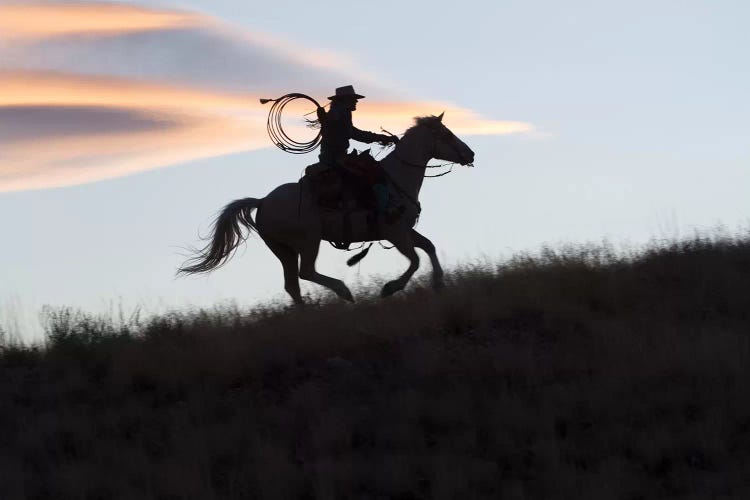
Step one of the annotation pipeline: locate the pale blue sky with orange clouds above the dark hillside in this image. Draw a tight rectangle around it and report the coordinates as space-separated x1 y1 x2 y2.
0 0 750 338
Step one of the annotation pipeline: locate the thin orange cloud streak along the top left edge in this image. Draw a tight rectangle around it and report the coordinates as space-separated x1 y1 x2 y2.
0 3 207 38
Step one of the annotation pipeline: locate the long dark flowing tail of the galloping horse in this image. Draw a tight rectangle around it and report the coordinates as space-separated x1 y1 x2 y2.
177 198 261 275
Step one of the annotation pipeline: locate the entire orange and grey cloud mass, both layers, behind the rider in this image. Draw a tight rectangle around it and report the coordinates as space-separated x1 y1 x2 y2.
0 2 533 192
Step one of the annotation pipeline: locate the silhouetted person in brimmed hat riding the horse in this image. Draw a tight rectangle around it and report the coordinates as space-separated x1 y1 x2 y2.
318 85 398 214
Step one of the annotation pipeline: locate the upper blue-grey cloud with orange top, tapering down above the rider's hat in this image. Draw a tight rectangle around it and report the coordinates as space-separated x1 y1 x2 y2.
0 4 374 95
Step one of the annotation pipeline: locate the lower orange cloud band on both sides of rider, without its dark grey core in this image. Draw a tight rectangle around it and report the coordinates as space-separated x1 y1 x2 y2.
0 71 532 192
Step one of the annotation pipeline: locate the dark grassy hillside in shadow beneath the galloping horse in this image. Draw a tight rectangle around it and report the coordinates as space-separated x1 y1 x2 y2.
0 238 750 499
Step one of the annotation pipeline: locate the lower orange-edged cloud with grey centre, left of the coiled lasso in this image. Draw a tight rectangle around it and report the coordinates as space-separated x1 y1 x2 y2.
0 72 266 192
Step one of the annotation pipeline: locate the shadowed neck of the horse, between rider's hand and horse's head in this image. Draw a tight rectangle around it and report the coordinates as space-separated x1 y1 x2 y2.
382 134 430 199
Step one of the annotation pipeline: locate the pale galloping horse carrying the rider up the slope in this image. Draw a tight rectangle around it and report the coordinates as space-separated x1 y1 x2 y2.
178 113 474 304
